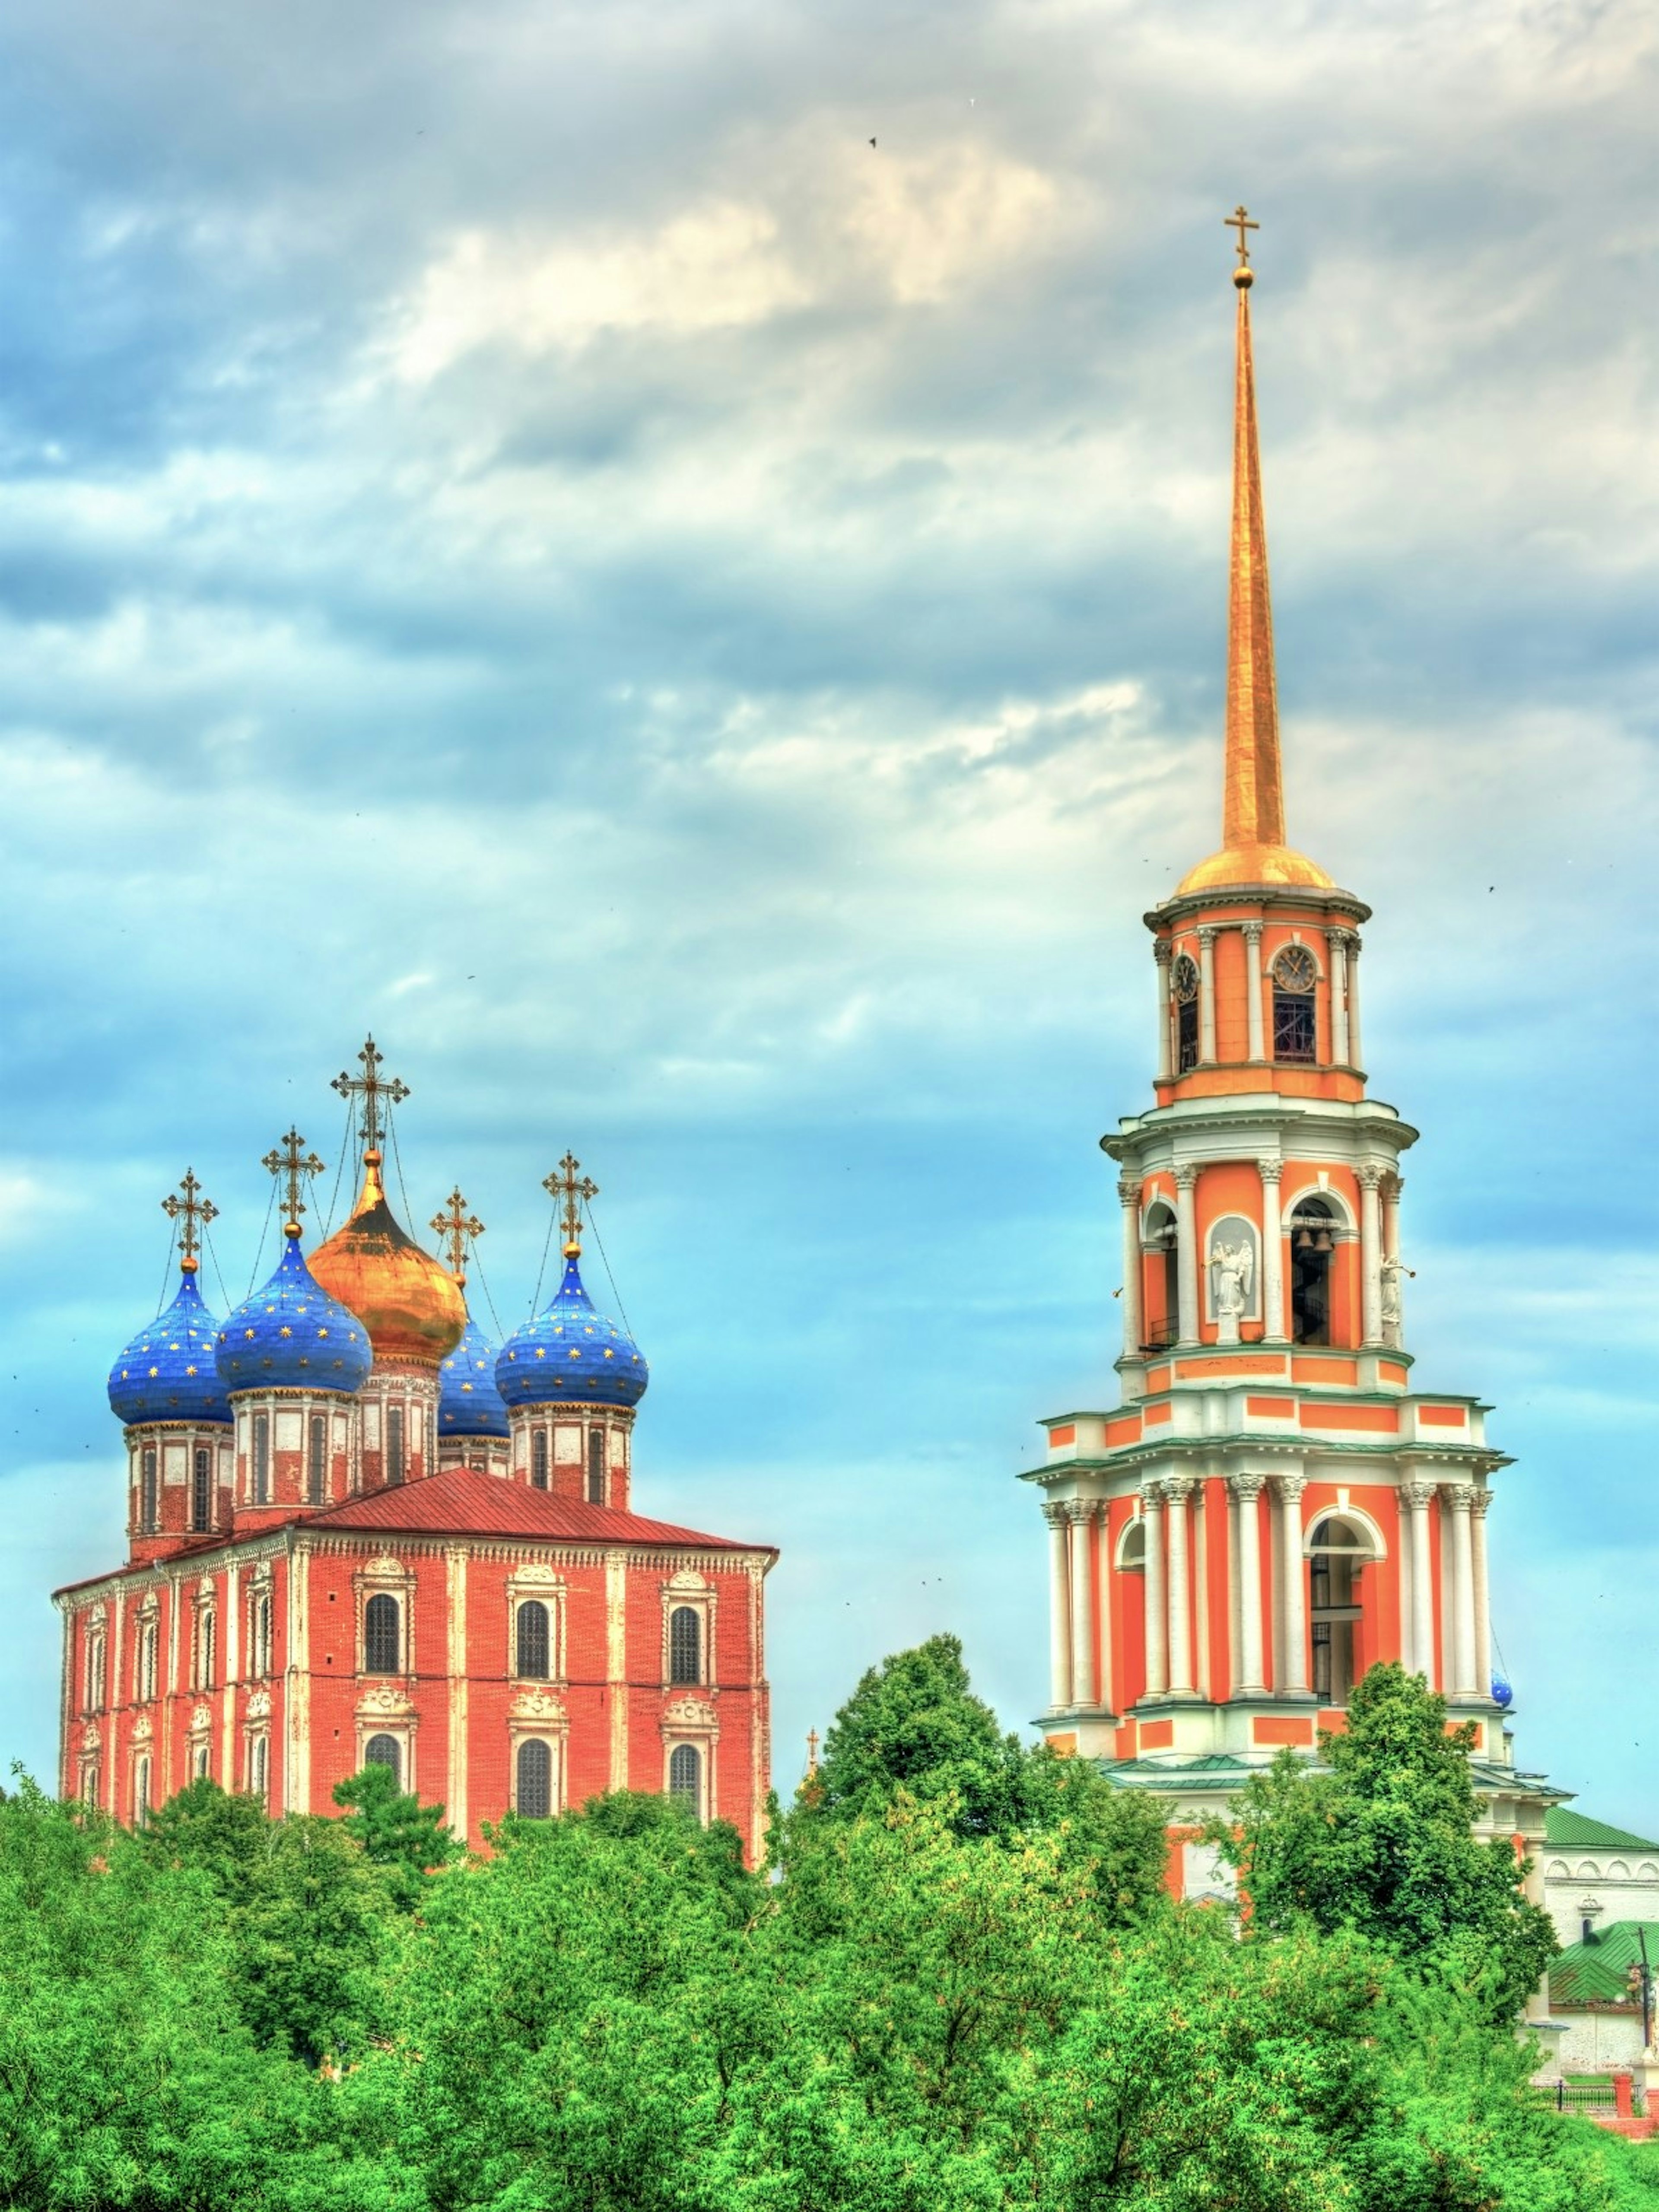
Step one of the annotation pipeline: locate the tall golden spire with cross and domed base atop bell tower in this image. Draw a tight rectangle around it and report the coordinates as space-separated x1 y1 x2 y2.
1177 208 1332 896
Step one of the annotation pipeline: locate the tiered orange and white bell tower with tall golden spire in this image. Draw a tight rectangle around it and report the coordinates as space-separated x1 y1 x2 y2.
1022 229 1564 1891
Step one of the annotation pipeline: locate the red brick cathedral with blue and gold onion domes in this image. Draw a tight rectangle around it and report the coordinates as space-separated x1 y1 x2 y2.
55 1062 776 1860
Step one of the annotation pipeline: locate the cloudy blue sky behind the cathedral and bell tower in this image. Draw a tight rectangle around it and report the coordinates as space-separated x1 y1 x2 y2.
0 0 1659 1836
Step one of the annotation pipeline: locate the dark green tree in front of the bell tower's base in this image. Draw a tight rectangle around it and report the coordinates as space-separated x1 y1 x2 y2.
1214 1663 1557 2022
